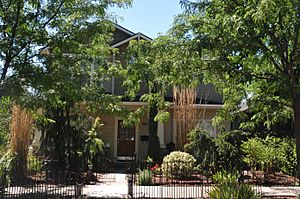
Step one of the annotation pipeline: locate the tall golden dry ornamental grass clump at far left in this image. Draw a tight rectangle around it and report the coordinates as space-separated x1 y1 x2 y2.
10 105 34 175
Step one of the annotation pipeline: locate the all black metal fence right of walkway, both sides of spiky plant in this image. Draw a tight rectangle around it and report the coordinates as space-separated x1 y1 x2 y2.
128 161 299 198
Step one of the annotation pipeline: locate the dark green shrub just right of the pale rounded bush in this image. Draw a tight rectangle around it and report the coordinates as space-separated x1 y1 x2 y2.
184 128 216 170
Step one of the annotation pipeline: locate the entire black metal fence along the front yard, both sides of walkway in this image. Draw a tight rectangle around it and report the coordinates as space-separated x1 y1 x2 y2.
0 157 299 199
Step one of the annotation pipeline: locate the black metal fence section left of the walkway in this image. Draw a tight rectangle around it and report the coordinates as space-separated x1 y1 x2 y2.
0 160 83 199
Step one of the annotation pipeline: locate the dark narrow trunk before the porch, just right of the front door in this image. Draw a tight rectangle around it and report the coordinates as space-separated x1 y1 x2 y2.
148 105 160 161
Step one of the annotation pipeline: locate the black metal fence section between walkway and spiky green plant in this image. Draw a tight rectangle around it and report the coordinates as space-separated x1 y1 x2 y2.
132 161 212 198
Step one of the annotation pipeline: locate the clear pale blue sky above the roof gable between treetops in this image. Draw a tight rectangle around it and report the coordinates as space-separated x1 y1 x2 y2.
109 0 183 38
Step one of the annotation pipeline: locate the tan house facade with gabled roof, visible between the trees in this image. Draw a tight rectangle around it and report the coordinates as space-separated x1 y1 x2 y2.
100 25 230 160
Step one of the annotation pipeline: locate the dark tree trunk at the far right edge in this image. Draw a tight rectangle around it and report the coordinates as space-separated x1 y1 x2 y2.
292 96 300 179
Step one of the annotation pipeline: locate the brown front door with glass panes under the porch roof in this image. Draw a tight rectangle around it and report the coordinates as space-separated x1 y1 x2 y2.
117 120 135 156
